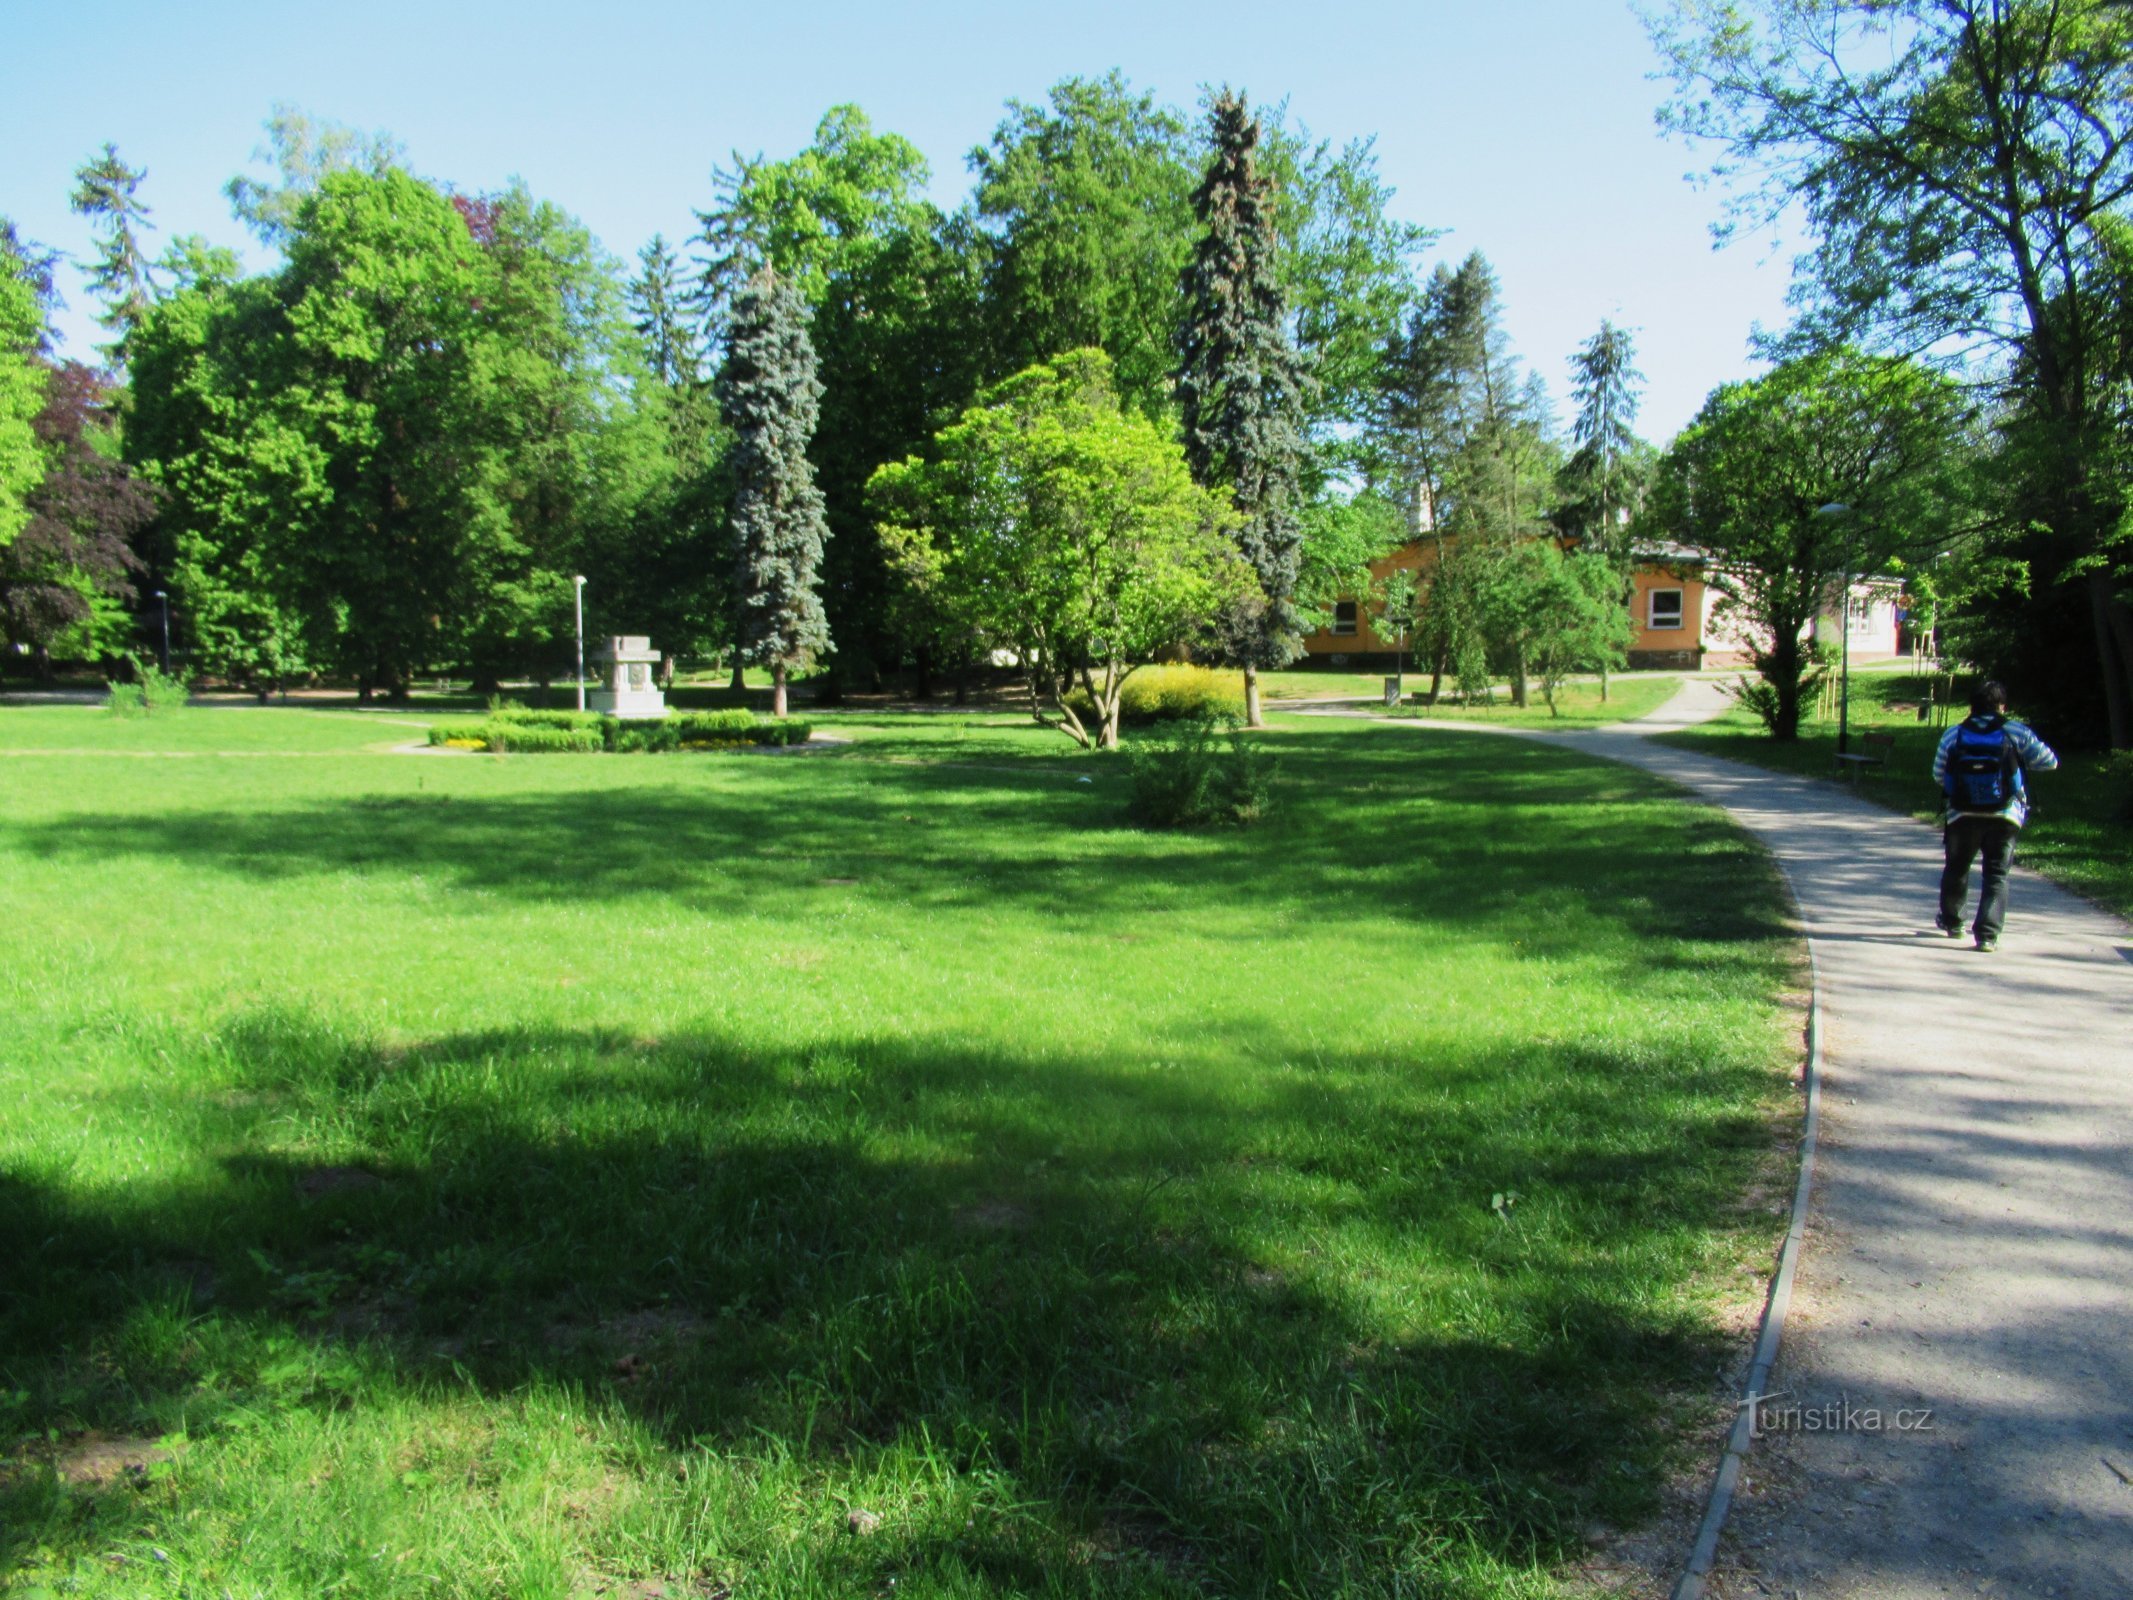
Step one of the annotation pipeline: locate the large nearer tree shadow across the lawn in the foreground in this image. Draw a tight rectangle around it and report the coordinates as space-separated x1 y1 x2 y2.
0 1013 1768 1594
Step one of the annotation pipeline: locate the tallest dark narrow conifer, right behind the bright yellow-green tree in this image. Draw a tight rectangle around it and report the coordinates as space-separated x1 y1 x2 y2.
1177 90 1305 727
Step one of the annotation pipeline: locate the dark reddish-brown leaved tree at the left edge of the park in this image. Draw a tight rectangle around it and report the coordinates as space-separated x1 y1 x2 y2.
0 361 156 674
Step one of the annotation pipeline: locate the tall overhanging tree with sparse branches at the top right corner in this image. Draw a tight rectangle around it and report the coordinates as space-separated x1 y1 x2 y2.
1655 0 2133 747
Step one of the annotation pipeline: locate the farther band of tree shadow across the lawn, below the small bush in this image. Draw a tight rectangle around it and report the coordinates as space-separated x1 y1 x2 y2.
0 730 1783 964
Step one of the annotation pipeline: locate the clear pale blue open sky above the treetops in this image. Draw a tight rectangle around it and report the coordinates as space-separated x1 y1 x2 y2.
0 0 1787 442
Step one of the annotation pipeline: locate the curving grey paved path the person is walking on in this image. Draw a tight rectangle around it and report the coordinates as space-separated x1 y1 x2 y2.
1348 681 2133 1600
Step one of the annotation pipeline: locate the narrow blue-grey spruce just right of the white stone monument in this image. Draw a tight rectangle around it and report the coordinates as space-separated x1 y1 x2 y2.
719 267 830 717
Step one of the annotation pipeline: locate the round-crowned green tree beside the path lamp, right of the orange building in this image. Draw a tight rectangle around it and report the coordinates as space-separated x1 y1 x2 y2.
1645 350 1967 740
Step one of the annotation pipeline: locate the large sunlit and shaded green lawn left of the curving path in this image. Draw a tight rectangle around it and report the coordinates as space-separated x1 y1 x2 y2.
0 708 1798 1600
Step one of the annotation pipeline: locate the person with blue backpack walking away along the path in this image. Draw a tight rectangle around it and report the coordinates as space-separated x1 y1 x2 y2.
1932 678 2058 951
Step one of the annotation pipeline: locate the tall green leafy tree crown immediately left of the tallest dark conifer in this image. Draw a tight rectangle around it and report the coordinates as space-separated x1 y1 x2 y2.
971 73 1194 416
